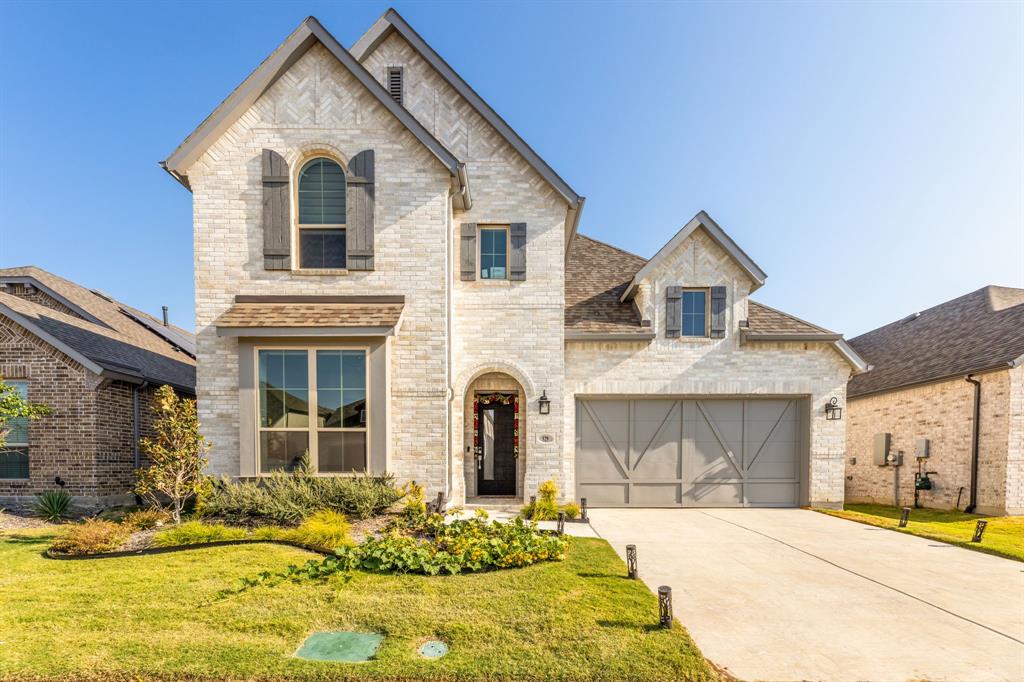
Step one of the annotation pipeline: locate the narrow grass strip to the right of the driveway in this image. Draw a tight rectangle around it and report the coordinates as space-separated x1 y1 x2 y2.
815 505 1024 561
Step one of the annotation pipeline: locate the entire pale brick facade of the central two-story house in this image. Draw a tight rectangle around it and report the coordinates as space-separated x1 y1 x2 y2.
186 19 850 504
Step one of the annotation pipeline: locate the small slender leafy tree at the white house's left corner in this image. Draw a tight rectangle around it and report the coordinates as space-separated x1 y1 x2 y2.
135 386 210 524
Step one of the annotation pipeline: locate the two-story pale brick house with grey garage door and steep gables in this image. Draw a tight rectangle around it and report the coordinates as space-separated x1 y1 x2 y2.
164 10 864 506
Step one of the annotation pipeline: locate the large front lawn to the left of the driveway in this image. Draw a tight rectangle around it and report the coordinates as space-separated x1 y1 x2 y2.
0 530 716 680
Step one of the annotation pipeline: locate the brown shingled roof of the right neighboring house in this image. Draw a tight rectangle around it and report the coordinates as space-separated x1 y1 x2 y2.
847 286 1024 397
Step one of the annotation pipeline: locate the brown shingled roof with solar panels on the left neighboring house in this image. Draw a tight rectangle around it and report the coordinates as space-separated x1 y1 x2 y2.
0 266 196 392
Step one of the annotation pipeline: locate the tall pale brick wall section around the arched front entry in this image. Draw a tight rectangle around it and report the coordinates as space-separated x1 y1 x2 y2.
364 34 566 500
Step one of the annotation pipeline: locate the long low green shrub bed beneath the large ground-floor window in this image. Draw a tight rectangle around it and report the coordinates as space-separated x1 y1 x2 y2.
198 468 402 525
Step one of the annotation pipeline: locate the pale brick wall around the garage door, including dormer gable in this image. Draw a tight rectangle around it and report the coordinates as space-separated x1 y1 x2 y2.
563 229 850 506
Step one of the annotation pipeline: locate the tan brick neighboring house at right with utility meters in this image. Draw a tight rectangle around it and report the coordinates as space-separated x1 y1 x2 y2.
846 287 1024 514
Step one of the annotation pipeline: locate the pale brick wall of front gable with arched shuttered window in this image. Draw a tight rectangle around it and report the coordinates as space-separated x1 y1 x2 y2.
188 45 450 489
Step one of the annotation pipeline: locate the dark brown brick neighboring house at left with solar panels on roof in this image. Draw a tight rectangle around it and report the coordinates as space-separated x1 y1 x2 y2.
0 267 196 507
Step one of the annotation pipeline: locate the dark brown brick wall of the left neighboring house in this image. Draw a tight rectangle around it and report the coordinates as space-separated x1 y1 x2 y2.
0 313 161 509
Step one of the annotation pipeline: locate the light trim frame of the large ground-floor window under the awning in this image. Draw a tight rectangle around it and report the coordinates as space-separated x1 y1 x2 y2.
253 344 374 477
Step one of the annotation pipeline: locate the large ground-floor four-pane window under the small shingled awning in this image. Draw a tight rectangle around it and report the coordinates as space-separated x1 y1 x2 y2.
259 349 368 473
